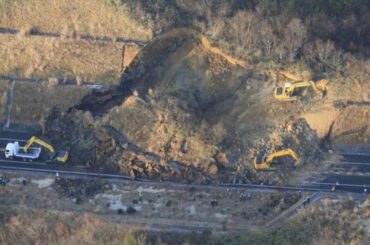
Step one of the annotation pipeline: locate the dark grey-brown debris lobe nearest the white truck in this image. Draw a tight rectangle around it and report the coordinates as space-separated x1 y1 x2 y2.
45 110 120 172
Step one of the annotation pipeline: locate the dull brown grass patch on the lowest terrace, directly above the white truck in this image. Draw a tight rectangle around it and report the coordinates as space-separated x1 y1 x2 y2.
11 82 89 125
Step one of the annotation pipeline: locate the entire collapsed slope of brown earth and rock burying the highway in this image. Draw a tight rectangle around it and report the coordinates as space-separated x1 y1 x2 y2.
47 28 319 182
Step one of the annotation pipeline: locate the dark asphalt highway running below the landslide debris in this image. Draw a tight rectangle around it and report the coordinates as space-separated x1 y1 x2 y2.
0 130 370 193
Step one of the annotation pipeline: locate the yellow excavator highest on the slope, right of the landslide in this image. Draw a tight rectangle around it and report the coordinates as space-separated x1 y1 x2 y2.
274 71 329 101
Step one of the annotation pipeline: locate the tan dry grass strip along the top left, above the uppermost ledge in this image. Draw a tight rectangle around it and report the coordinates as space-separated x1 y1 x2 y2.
0 0 151 40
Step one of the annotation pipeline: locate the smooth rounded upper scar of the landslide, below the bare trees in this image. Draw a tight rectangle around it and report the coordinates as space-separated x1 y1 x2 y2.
122 29 245 109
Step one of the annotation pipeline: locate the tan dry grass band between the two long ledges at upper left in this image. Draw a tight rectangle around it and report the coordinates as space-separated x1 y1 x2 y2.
0 35 131 83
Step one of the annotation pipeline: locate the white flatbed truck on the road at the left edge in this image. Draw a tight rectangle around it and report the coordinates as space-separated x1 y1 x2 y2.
5 141 41 161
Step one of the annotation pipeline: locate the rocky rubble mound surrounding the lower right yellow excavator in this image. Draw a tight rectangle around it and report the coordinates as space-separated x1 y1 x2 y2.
239 119 324 184
